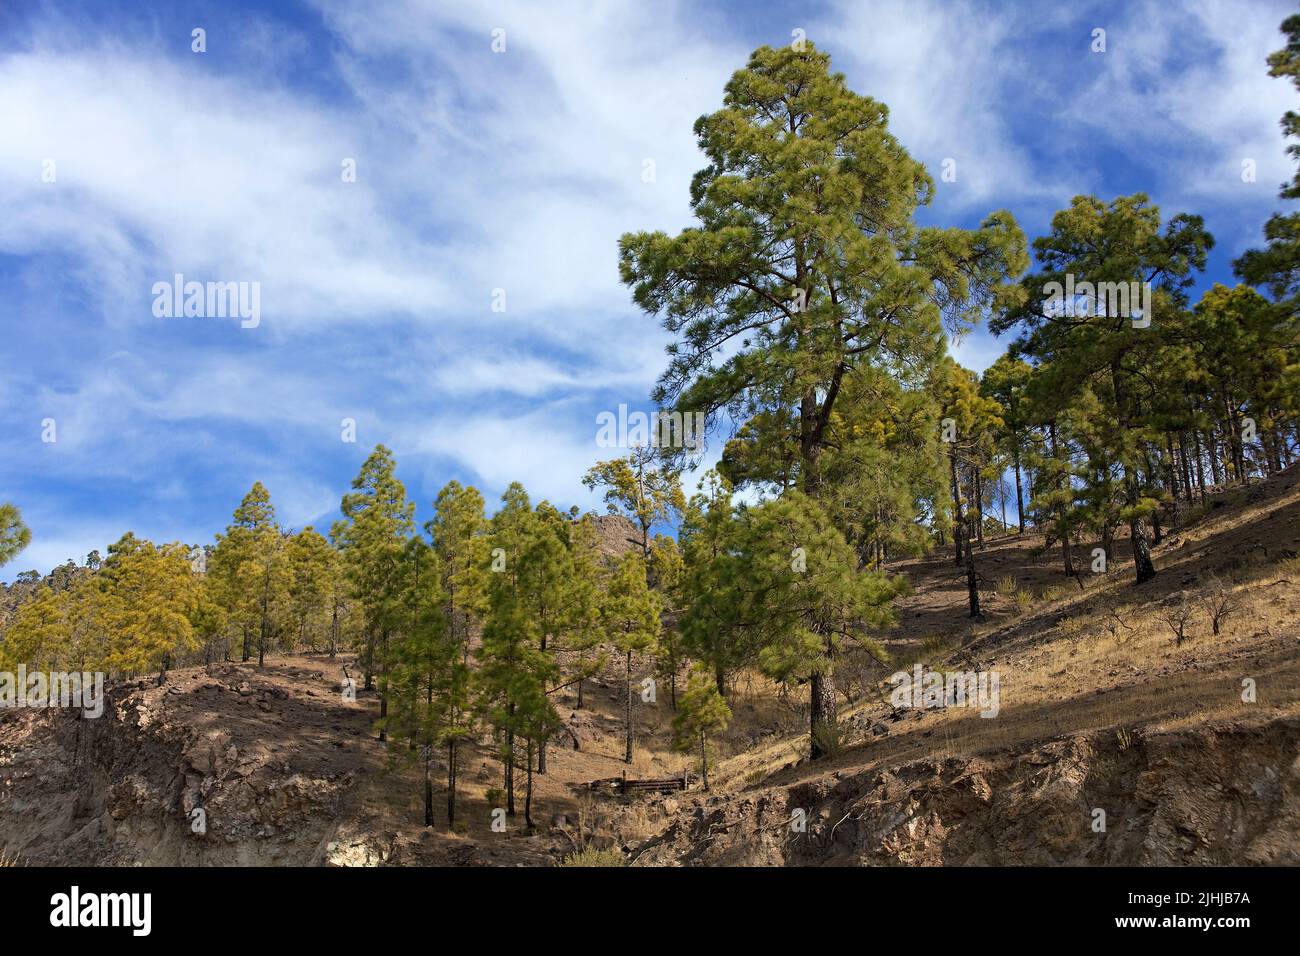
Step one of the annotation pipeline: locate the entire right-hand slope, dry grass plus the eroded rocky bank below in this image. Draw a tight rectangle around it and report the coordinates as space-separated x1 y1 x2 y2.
637 467 1300 865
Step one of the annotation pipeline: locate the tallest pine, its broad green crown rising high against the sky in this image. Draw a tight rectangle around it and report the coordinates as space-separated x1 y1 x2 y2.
619 44 1027 738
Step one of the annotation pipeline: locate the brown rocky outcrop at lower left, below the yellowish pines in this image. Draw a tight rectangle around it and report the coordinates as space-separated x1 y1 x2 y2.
0 672 354 865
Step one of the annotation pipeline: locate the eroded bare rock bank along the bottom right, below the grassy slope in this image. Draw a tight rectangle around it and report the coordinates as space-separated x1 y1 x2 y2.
637 718 1300 866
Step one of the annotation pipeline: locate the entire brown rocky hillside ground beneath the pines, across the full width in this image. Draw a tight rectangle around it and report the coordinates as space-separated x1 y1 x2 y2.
0 478 1300 865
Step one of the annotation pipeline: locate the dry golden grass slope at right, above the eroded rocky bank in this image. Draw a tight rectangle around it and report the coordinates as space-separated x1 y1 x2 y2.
696 468 1300 790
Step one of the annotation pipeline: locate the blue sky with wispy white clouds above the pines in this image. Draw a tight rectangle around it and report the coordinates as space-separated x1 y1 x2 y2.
0 0 1296 579
